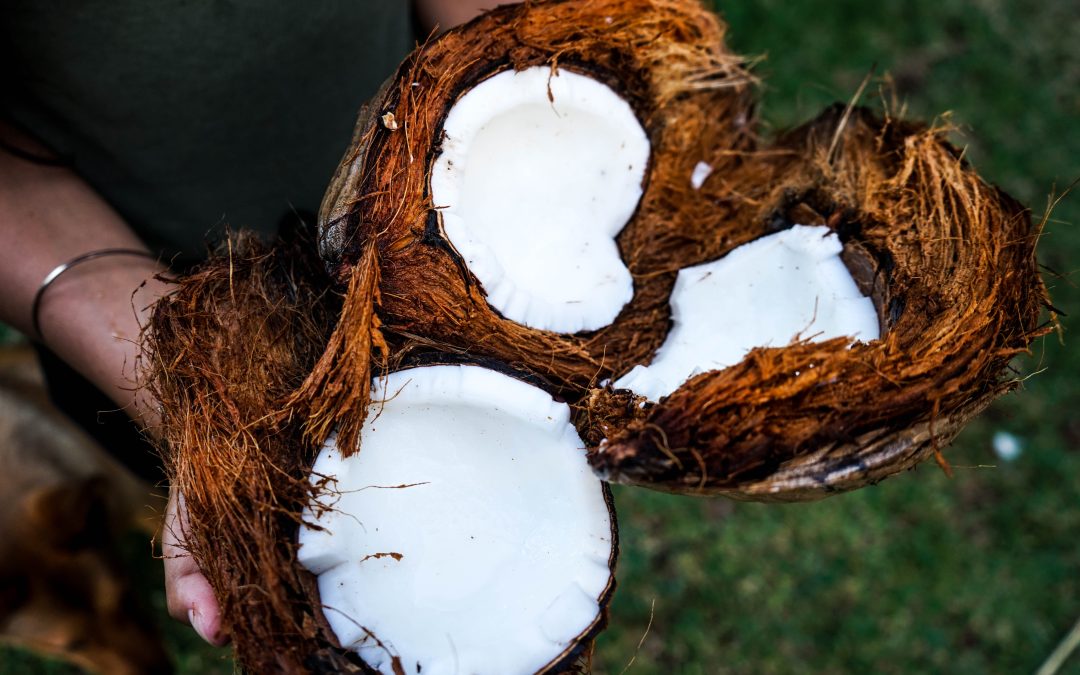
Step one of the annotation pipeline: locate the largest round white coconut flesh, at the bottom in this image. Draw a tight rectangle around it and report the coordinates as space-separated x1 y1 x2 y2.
299 366 613 675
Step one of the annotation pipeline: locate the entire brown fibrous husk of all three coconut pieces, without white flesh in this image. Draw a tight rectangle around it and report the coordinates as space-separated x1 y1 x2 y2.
145 0 1047 673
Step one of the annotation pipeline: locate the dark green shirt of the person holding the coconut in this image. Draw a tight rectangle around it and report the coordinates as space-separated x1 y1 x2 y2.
0 0 411 259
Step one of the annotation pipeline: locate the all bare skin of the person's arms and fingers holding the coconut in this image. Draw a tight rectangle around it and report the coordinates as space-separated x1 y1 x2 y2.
0 0 500 645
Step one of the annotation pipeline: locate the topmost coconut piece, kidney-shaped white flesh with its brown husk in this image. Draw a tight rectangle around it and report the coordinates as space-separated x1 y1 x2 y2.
320 0 753 400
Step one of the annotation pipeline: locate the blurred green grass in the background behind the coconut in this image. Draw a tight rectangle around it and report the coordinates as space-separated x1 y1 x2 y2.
0 0 1080 675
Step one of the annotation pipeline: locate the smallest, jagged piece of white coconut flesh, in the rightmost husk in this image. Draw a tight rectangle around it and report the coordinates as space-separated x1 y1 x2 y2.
615 225 880 401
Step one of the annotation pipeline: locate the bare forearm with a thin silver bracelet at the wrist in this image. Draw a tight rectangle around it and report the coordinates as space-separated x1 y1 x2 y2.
0 122 165 417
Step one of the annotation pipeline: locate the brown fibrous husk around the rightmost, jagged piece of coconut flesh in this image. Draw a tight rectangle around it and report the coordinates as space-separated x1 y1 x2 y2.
580 106 1047 494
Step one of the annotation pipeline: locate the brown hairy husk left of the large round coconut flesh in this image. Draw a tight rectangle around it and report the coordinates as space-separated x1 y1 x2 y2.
144 230 382 673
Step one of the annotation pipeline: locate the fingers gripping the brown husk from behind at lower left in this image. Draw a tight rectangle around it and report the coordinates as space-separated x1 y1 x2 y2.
161 489 229 647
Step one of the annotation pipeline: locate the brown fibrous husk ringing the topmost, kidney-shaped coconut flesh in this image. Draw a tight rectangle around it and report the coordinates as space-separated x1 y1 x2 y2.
320 0 753 399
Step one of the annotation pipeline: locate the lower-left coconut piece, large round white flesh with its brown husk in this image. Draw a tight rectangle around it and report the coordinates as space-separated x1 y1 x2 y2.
145 234 618 673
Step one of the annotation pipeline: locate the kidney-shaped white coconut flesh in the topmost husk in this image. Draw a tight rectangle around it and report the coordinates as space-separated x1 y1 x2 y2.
431 67 649 333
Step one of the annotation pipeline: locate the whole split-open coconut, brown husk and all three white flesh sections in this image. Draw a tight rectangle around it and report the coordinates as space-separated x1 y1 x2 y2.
148 0 1047 673
